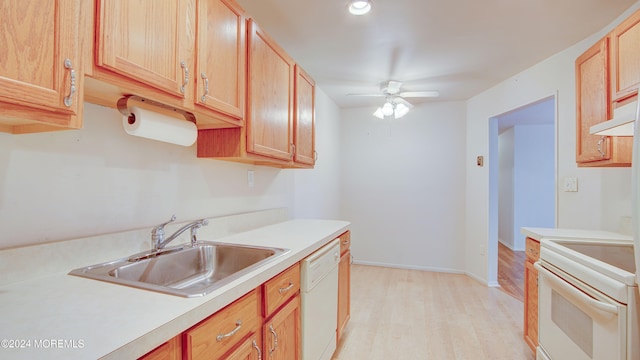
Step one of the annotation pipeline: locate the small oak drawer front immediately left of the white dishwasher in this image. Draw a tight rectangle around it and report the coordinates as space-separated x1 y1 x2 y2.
264 263 300 317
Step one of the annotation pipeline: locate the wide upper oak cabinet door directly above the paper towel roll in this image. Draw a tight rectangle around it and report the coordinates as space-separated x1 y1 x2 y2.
96 0 193 98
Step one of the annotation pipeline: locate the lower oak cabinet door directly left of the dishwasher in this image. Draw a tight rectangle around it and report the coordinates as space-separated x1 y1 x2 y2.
262 295 301 360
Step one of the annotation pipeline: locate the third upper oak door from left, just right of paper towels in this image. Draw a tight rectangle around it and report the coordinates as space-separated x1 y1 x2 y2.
195 0 246 120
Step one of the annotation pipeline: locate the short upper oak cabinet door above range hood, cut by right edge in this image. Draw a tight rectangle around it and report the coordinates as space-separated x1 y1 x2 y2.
611 11 640 101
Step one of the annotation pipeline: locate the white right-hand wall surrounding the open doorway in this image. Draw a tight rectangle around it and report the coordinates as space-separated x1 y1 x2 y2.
466 3 640 281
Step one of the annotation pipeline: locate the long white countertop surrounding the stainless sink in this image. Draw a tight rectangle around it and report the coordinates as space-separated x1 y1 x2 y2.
0 220 349 359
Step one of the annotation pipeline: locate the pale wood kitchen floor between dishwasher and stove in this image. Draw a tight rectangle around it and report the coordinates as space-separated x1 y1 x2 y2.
333 265 535 360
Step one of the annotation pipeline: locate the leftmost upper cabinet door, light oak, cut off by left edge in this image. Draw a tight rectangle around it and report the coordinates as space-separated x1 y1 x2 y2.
0 0 82 114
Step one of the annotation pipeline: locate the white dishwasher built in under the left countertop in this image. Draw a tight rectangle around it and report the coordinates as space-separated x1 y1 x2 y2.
300 239 340 360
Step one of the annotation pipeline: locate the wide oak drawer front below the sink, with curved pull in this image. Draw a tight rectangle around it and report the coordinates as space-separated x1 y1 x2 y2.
183 290 262 359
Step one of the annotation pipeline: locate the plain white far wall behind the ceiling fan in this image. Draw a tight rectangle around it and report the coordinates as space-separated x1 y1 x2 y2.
341 102 465 272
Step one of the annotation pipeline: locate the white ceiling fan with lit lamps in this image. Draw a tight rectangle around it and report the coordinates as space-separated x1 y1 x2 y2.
349 80 440 119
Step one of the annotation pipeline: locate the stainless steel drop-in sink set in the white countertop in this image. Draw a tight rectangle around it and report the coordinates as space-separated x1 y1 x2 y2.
69 241 288 297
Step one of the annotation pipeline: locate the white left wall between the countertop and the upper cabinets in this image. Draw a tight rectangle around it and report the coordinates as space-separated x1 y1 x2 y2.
0 90 339 248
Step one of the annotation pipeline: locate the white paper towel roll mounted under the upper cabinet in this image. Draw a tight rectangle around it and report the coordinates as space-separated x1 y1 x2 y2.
122 106 198 146
